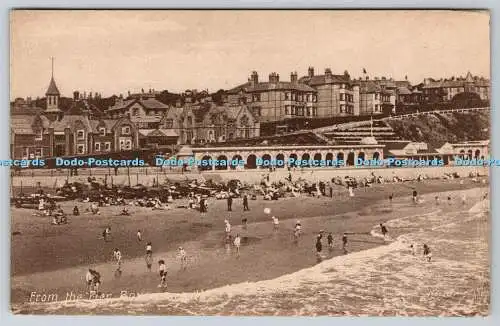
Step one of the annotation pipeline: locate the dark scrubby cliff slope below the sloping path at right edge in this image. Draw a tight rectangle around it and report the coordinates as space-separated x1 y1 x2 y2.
388 111 490 146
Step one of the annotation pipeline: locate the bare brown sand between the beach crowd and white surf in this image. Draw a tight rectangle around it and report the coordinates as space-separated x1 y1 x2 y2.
12 180 487 302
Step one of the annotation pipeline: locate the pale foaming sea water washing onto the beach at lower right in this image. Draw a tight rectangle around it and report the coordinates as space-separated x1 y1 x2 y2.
13 194 490 316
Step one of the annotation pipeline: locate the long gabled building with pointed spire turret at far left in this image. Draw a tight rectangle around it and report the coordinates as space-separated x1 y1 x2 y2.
10 72 139 159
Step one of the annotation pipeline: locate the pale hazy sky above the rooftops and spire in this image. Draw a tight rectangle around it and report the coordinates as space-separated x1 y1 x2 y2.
11 11 490 98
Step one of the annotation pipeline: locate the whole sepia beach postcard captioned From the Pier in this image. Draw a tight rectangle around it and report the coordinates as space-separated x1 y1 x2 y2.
9 9 490 316
